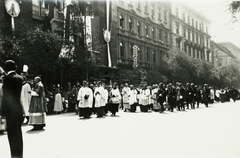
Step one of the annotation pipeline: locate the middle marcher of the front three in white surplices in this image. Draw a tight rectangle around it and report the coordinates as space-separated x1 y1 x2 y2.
94 81 106 117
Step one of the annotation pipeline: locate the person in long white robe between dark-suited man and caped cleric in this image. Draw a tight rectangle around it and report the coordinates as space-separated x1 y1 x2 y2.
21 77 31 124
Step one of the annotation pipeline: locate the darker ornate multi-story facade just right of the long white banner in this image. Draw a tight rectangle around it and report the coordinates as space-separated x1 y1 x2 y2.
111 0 170 67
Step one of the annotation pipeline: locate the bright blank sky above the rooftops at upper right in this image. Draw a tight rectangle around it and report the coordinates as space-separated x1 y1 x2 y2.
173 0 240 48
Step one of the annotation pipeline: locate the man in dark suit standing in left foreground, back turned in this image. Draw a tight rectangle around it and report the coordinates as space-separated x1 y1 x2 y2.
2 60 23 158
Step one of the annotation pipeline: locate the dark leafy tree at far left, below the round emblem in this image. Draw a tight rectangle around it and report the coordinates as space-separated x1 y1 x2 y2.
2 21 63 75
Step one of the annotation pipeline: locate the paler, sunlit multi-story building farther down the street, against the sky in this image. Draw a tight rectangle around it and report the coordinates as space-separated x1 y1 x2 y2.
170 2 213 62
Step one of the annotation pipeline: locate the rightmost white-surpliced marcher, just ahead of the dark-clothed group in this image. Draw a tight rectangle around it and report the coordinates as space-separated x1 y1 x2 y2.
139 84 150 112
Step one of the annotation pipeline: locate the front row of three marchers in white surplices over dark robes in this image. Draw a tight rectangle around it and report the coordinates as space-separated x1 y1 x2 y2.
77 81 121 118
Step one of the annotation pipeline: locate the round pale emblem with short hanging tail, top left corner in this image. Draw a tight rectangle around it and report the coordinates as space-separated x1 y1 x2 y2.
5 0 20 30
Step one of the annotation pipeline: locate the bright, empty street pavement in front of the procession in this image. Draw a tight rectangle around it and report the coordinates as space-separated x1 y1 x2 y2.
0 101 240 158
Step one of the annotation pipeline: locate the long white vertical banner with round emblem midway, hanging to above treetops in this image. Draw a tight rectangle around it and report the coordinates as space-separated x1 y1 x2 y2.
103 0 112 67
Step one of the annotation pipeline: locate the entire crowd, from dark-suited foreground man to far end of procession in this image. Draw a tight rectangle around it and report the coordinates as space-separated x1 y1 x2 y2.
0 60 239 157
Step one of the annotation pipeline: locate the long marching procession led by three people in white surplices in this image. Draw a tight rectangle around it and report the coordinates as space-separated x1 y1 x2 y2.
49 81 239 118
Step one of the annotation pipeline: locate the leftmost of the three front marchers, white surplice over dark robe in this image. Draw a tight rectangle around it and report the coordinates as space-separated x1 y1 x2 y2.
77 81 93 118
